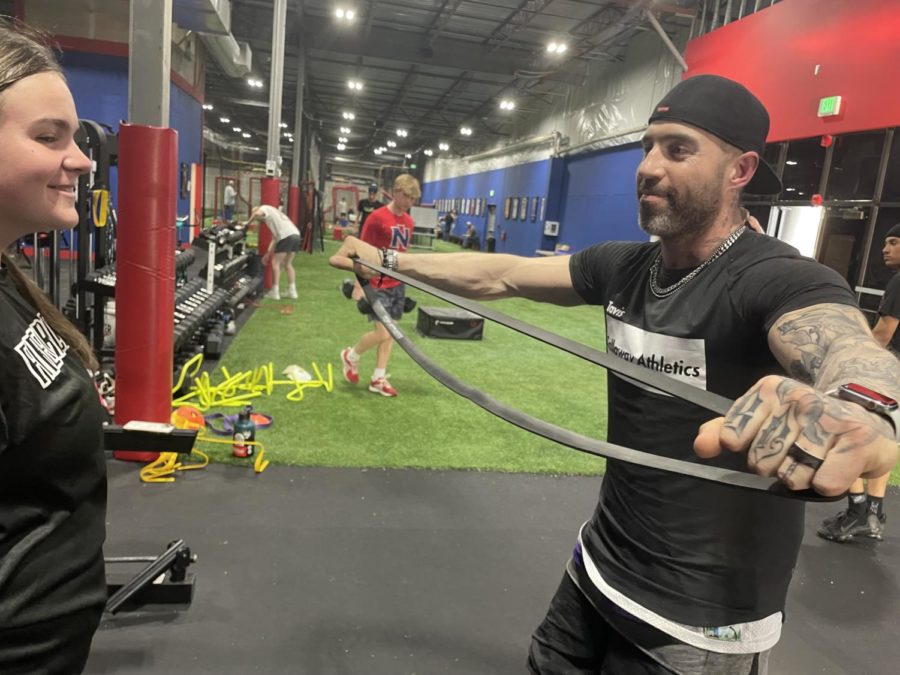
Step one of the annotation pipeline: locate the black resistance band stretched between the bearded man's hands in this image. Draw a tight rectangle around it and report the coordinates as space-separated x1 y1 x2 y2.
356 259 843 502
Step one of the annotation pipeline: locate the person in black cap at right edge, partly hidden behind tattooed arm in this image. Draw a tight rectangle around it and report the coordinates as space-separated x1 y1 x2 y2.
817 223 900 543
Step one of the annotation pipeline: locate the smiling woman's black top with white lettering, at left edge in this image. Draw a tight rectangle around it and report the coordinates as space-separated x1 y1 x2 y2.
0 270 106 629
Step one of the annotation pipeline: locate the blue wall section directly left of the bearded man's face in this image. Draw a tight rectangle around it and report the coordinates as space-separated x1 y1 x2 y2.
558 145 648 251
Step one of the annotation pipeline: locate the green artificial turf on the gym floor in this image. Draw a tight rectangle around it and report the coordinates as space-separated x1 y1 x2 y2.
188 241 900 483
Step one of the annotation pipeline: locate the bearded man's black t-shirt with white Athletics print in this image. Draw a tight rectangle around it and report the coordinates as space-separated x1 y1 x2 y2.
570 231 856 626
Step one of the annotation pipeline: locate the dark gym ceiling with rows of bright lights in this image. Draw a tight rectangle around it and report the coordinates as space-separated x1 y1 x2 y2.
206 0 704 163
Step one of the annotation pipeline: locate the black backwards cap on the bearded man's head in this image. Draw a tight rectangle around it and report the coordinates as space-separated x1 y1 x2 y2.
650 75 781 194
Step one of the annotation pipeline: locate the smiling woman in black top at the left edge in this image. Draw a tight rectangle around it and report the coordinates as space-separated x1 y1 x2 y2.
0 20 106 675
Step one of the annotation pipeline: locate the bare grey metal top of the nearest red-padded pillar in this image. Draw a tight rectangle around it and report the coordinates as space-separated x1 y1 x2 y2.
128 0 172 127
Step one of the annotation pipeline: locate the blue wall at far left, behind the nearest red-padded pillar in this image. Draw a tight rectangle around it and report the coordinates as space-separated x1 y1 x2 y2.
63 52 203 236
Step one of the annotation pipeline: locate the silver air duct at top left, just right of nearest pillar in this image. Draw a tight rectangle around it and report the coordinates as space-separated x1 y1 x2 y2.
172 0 253 77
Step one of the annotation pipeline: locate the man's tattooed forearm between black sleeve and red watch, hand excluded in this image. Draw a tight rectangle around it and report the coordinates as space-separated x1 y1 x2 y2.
769 304 900 399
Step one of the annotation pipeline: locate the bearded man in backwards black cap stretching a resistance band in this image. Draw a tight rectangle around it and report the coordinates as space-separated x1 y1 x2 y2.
331 75 900 674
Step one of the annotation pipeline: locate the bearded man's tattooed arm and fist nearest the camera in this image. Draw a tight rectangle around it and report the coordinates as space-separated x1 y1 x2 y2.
694 304 900 488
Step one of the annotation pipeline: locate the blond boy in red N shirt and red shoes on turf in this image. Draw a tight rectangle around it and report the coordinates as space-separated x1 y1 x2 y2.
341 174 422 397
